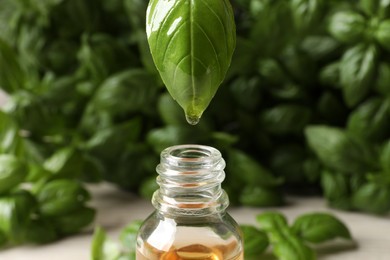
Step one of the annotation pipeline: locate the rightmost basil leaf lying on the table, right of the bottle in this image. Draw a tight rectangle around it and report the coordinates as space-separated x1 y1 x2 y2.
292 213 351 243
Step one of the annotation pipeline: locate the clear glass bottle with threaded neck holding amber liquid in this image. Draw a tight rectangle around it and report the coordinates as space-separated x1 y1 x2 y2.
136 145 244 260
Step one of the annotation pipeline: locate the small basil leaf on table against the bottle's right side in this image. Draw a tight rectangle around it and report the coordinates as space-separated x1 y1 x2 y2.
240 225 269 259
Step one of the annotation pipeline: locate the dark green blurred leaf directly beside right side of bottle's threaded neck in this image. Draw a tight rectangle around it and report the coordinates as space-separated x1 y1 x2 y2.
226 149 283 188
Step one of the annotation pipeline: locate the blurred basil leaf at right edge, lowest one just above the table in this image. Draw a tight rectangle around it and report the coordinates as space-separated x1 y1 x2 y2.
352 182 390 214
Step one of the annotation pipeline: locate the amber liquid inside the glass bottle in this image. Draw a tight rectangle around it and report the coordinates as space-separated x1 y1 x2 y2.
137 243 244 260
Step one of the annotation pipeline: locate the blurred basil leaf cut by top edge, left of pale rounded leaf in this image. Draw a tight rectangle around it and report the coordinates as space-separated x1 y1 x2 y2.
291 0 326 32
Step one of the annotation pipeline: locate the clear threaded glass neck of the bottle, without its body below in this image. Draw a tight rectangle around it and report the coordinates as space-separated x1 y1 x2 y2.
152 145 229 216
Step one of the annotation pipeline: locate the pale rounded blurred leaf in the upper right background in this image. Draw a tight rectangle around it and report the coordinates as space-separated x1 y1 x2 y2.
328 11 367 43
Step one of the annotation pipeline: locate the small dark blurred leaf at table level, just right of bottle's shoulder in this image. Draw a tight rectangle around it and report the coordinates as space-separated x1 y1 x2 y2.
240 186 284 207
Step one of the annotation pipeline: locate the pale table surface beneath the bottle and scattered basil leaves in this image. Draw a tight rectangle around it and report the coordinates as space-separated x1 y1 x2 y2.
0 184 390 260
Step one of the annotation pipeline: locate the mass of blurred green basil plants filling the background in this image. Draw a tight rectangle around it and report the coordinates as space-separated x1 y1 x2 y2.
0 0 390 248
